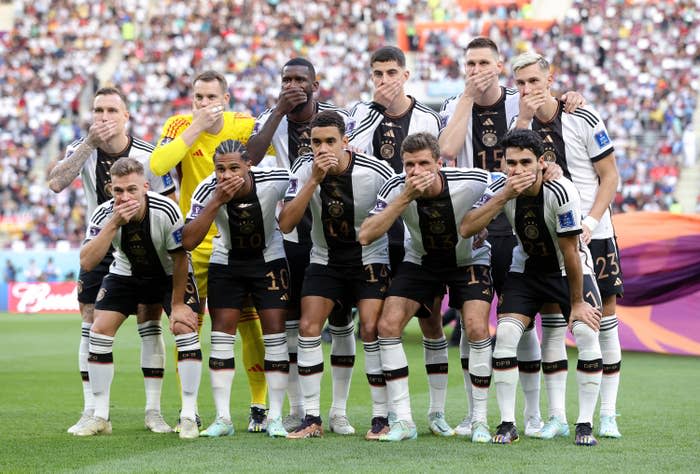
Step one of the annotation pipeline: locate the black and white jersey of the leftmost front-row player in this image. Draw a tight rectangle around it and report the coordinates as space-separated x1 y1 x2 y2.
85 191 184 277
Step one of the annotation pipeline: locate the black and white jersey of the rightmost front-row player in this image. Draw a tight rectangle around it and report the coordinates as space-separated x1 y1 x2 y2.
476 177 593 276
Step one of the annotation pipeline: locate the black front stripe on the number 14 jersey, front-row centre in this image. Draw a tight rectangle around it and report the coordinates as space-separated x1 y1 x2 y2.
319 159 362 266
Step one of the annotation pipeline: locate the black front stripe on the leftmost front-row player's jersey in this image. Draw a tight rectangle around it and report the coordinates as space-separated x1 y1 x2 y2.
121 195 166 278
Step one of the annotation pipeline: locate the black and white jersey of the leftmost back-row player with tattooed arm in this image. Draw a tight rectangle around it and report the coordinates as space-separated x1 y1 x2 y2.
63 136 175 221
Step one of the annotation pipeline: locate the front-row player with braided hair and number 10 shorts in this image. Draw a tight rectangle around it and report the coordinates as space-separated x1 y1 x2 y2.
183 140 289 437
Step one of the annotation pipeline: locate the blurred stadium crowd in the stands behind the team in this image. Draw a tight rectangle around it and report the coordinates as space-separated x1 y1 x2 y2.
0 0 700 260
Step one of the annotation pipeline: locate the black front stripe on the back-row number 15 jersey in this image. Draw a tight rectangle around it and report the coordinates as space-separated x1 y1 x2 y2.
472 87 508 171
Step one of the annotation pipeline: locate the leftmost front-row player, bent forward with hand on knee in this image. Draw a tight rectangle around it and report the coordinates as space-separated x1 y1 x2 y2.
74 158 202 438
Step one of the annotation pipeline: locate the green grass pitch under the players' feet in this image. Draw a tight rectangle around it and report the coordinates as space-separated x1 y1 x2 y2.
0 314 700 473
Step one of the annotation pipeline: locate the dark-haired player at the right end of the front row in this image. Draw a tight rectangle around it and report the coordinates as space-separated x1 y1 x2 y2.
460 130 603 446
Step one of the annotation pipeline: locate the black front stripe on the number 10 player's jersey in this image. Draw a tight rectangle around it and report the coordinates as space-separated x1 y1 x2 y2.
226 173 265 262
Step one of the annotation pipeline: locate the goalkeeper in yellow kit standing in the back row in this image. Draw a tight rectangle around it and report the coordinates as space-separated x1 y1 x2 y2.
150 71 267 431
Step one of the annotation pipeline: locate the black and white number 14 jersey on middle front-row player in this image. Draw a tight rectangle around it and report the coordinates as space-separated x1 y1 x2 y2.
285 153 394 266
